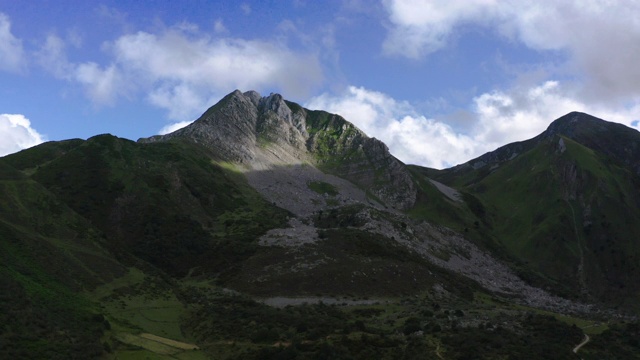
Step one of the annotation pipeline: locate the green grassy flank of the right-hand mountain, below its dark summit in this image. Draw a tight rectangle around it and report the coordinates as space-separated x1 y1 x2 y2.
427 137 640 305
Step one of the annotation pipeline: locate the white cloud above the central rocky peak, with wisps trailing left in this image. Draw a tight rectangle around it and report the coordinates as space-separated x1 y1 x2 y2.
40 24 323 121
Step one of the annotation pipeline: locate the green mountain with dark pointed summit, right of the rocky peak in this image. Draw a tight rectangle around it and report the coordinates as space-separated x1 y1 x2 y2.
430 113 640 306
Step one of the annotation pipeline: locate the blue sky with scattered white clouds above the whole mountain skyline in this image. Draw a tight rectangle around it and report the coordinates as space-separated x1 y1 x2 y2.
0 0 640 168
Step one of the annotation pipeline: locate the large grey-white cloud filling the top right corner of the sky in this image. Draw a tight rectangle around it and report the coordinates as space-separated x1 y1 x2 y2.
383 0 640 101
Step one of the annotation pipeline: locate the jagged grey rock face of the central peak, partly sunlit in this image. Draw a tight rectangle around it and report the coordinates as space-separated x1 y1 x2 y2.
138 90 416 209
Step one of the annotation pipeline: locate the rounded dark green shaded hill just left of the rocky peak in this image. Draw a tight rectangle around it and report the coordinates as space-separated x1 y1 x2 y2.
9 135 286 275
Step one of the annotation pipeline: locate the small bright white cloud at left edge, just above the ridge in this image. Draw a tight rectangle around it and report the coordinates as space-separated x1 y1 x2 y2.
0 114 45 156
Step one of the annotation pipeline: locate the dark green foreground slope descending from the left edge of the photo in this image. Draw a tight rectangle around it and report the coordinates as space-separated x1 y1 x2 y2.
0 159 123 359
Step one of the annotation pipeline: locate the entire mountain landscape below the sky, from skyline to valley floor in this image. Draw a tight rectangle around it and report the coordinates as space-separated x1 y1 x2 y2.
0 91 639 359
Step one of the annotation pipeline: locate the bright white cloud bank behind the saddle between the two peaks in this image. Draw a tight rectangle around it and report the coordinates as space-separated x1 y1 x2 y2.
306 81 640 168
